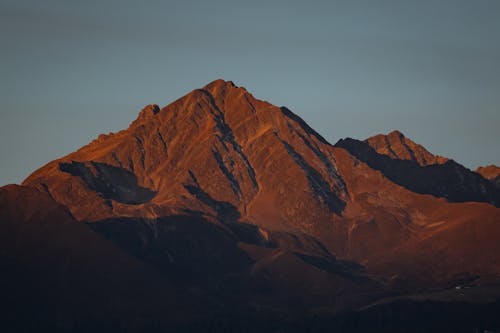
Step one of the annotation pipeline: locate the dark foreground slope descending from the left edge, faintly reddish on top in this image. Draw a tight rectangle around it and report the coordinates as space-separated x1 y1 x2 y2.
0 185 192 331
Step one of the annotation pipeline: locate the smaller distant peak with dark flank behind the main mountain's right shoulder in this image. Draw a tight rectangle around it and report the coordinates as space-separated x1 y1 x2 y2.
335 132 500 207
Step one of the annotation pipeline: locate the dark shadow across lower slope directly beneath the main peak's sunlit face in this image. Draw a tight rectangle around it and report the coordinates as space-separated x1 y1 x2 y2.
87 215 381 311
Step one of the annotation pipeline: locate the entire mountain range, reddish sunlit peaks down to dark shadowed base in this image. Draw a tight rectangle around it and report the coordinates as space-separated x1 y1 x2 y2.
0 80 500 332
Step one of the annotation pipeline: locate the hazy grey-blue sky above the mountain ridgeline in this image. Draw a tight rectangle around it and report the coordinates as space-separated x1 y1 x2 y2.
0 0 500 186
